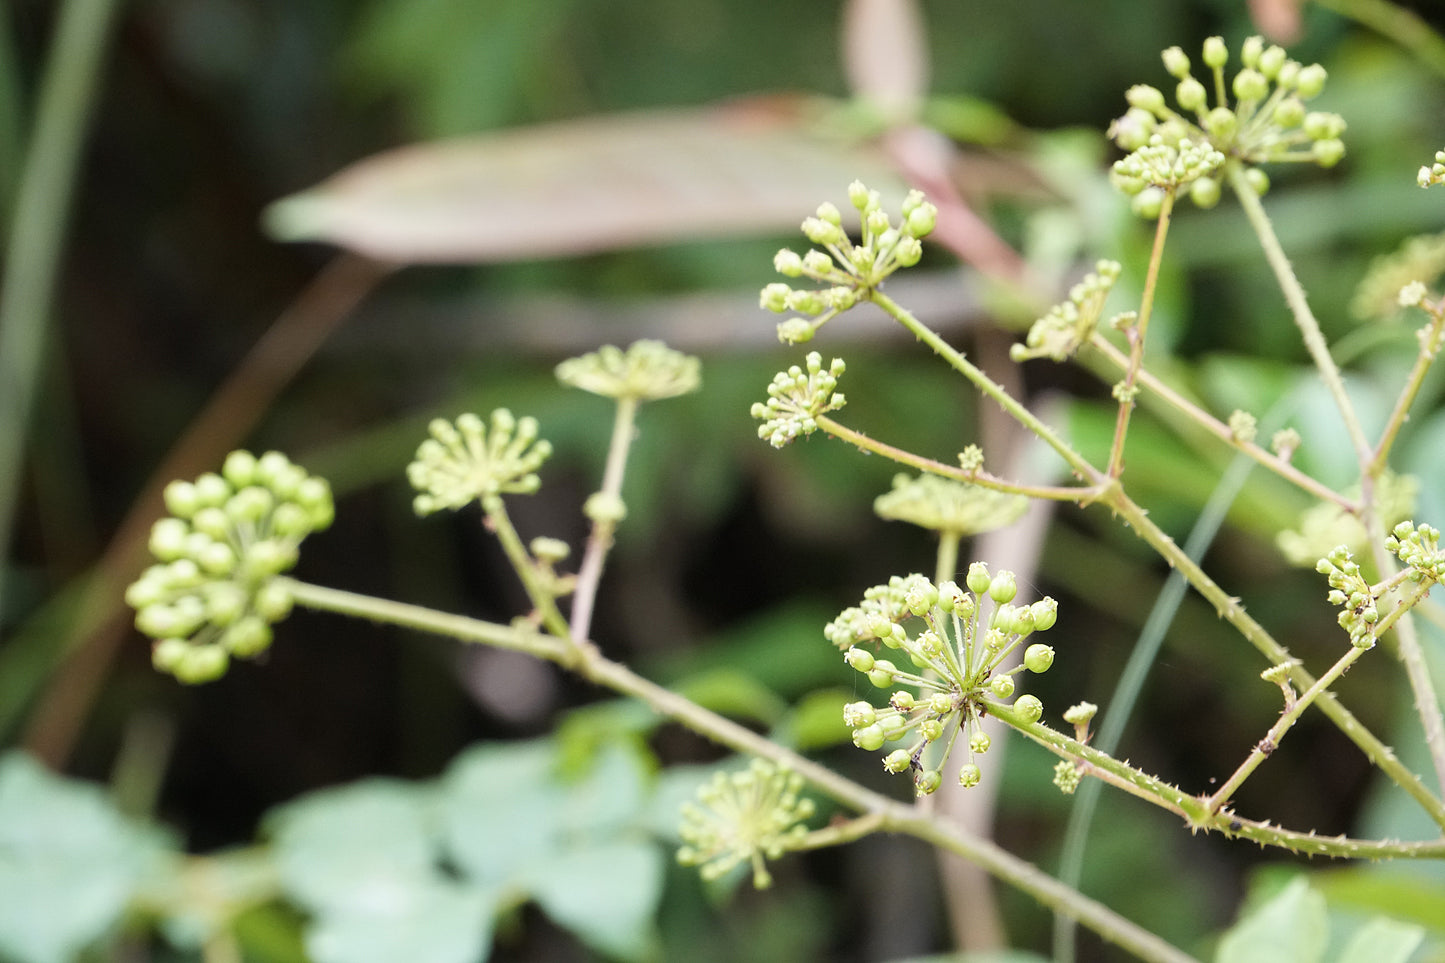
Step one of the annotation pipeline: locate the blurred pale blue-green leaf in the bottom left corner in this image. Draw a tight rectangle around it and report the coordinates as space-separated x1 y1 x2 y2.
0 752 165 963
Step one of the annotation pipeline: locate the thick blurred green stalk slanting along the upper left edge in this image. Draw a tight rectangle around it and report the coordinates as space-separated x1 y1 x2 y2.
0 0 116 613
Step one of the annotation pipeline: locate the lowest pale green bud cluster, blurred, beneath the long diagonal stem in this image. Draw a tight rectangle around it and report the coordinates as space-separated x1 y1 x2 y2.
678 759 814 889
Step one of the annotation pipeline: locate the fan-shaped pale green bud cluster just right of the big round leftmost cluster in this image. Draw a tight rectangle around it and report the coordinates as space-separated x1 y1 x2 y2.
406 408 552 515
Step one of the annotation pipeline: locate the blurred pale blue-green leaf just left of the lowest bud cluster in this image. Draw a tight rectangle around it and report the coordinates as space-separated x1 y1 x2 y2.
529 840 665 959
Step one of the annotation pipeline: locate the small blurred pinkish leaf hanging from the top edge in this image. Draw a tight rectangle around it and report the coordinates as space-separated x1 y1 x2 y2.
842 0 928 110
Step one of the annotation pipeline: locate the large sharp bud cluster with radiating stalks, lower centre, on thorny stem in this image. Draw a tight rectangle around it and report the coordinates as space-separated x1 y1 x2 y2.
824 562 1058 795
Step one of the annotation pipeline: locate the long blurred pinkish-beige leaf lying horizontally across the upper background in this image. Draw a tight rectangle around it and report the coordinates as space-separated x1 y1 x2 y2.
264 101 897 263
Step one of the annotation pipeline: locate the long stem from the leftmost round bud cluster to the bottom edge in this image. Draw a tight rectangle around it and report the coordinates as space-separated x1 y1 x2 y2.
282 578 1196 963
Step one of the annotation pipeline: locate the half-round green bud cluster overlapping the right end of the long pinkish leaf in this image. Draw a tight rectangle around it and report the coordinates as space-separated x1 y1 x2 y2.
760 181 938 344
